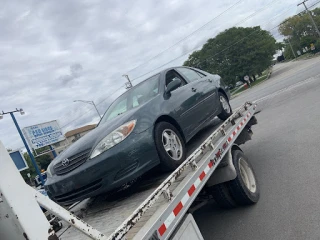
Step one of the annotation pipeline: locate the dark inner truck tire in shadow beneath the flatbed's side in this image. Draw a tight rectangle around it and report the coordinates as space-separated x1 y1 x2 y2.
208 183 237 209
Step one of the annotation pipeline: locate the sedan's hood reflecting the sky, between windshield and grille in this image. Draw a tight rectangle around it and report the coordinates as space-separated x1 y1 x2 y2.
51 111 135 165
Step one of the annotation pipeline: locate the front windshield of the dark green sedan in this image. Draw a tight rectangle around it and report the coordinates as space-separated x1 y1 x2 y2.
99 74 159 125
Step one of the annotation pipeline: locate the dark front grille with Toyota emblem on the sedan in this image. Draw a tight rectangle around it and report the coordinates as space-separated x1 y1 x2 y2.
53 149 90 175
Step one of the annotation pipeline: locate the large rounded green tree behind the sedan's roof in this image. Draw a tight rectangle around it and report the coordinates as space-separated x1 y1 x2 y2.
184 27 279 84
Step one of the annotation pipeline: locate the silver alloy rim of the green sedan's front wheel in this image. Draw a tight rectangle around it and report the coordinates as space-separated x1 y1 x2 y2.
162 129 183 161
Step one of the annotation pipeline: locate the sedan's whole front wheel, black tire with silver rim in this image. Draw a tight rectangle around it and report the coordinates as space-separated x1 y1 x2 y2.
154 122 186 171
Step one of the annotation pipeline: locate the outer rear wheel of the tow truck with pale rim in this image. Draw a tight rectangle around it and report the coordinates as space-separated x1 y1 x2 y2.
226 150 260 205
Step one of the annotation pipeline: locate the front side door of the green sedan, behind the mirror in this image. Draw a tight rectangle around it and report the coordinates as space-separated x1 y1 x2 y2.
165 69 202 139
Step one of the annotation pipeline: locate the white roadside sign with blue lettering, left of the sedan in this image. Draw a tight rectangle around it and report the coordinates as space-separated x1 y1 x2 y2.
22 121 65 149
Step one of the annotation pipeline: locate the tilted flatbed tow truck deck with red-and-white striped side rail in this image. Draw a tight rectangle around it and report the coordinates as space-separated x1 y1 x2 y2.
0 103 256 240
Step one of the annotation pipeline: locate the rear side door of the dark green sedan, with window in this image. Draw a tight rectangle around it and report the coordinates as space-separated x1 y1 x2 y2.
177 67 216 131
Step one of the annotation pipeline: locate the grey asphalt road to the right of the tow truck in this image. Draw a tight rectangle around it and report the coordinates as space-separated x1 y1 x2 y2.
194 58 320 240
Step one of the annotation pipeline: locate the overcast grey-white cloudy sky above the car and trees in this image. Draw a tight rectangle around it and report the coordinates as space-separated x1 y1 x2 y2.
0 0 318 149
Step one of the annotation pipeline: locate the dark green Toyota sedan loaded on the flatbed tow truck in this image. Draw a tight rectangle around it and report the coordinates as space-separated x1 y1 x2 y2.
45 67 232 204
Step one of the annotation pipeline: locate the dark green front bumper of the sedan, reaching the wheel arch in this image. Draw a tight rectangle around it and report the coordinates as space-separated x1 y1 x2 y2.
45 128 160 205
